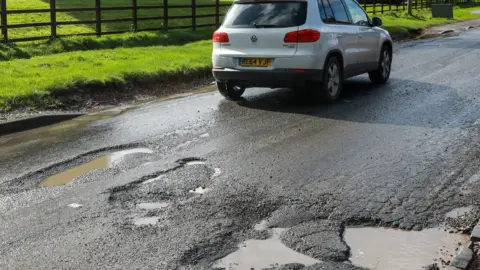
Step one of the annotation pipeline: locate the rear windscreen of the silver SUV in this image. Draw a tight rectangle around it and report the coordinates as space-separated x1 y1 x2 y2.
223 1 307 28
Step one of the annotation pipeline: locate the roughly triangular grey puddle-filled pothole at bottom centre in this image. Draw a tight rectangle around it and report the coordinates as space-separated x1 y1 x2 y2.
214 228 320 270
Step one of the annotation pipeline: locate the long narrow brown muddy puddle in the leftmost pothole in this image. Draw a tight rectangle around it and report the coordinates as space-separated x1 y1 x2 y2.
40 148 152 187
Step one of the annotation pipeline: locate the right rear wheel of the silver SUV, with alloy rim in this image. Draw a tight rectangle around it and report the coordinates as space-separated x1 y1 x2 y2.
319 56 343 103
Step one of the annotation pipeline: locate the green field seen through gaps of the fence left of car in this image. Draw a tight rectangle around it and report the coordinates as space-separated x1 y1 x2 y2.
2 0 231 39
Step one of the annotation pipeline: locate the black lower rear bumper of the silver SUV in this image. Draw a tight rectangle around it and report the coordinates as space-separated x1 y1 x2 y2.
212 69 323 88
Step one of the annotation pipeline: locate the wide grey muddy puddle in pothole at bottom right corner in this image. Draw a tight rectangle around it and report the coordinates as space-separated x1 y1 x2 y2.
344 228 468 270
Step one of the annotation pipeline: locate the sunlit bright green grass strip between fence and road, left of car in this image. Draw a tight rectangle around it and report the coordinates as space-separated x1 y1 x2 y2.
0 41 211 111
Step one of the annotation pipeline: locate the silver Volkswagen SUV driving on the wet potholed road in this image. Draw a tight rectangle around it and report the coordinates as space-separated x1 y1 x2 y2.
212 0 392 102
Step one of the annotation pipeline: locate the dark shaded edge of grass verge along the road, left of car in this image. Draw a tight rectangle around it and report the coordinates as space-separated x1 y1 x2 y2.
0 67 211 113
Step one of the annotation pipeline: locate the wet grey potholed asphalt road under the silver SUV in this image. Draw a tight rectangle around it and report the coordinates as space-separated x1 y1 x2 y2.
0 30 480 269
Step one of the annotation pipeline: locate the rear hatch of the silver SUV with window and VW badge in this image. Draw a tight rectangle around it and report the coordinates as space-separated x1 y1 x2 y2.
220 0 307 58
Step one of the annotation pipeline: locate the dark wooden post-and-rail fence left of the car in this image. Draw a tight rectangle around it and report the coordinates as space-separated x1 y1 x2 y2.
0 0 231 42
